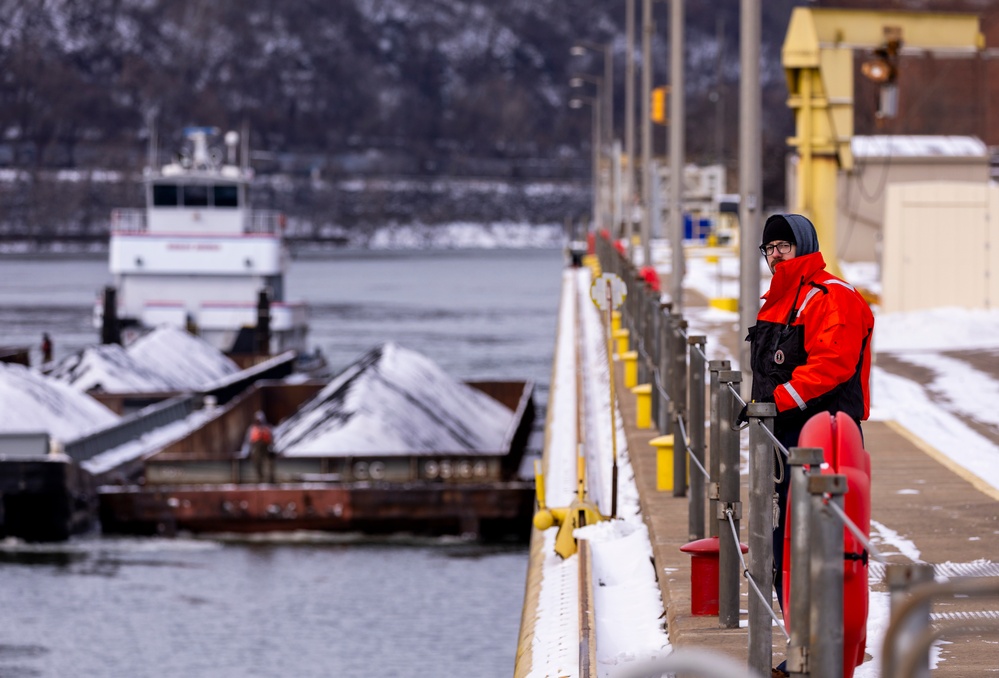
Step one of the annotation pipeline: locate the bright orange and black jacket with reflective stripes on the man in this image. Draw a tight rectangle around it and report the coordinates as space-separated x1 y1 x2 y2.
747 252 874 423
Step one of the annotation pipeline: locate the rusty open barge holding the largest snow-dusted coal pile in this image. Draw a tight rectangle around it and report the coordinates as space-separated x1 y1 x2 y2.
98 346 535 540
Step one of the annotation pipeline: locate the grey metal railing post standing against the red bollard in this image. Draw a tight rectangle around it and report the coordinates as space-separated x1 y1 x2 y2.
715 370 742 629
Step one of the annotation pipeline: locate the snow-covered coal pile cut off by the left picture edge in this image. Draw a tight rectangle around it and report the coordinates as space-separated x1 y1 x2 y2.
0 363 118 441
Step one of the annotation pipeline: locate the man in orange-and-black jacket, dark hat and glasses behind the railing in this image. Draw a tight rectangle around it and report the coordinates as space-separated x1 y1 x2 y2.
747 214 874 632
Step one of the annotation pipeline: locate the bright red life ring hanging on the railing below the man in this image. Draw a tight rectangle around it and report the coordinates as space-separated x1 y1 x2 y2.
783 412 871 678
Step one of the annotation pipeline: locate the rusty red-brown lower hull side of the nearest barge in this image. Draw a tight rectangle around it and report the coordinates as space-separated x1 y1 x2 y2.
100 481 534 541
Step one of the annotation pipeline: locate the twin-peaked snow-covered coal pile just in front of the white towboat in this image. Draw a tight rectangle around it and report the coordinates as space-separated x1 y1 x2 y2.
50 326 239 393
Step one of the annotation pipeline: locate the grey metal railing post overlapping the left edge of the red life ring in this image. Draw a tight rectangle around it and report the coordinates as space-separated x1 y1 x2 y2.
784 447 824 678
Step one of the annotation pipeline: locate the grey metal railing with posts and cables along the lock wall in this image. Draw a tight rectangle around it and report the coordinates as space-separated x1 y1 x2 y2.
596 238 999 678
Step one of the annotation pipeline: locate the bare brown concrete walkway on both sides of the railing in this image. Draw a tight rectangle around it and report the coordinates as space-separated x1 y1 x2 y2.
616 290 999 677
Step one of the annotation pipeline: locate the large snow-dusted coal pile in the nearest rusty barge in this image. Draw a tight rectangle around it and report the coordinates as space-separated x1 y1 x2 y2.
274 342 514 456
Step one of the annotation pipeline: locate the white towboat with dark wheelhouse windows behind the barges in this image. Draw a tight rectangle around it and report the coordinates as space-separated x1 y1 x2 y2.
95 127 308 354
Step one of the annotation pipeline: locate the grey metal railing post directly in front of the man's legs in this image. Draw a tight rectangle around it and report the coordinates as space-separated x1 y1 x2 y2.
746 403 777 673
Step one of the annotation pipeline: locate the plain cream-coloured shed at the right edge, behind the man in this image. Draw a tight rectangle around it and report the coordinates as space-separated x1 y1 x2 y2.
881 181 999 313
